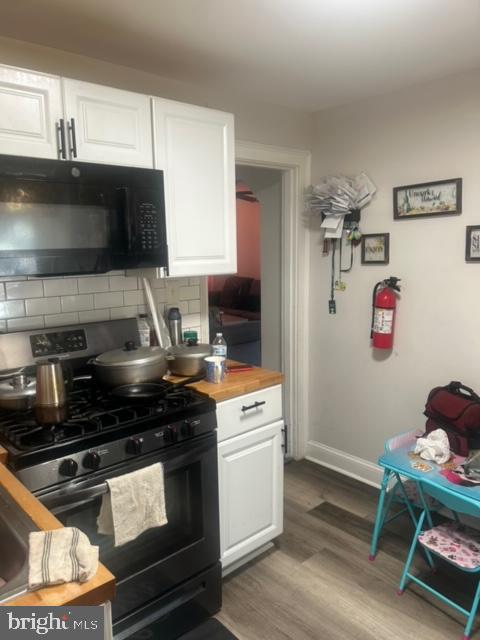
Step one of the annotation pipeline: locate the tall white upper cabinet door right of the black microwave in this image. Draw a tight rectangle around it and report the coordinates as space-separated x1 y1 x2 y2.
154 98 237 276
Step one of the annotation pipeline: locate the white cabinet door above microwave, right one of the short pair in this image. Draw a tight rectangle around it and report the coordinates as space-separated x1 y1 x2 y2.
63 79 153 168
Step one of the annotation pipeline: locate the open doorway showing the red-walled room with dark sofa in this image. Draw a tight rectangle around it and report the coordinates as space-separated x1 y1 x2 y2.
208 165 283 371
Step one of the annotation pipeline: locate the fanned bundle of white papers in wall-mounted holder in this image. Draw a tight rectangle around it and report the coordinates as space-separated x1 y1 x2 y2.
307 173 377 238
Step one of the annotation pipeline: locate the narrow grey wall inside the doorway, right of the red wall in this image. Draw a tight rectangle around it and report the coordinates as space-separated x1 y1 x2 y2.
237 166 282 371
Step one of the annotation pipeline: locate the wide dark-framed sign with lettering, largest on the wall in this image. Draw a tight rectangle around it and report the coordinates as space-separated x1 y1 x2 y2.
393 178 462 220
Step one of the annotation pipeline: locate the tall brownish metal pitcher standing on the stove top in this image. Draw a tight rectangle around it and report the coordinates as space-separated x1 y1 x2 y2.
35 358 67 425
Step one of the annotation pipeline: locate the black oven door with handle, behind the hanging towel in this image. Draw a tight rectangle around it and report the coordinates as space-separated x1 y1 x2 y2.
38 433 220 622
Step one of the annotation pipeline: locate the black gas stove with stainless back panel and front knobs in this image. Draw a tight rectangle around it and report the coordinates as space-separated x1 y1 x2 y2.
0 319 221 640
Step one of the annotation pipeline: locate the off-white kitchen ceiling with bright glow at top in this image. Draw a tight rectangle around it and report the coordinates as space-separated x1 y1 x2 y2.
0 0 480 111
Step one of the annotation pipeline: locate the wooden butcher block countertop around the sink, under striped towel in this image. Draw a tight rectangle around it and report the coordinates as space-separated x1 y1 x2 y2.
0 462 115 607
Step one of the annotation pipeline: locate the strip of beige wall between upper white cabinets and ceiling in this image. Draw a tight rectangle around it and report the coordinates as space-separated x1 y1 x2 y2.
0 38 313 148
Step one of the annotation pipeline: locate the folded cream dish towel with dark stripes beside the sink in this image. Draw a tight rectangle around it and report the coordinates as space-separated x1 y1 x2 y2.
28 527 98 590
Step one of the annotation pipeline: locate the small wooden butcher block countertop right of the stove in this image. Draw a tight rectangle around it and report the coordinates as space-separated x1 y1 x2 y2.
168 360 283 402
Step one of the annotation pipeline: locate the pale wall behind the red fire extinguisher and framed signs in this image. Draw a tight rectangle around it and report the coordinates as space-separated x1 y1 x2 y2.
308 67 480 479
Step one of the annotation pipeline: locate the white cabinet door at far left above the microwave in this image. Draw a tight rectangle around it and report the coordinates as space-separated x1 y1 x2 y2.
0 66 63 158
